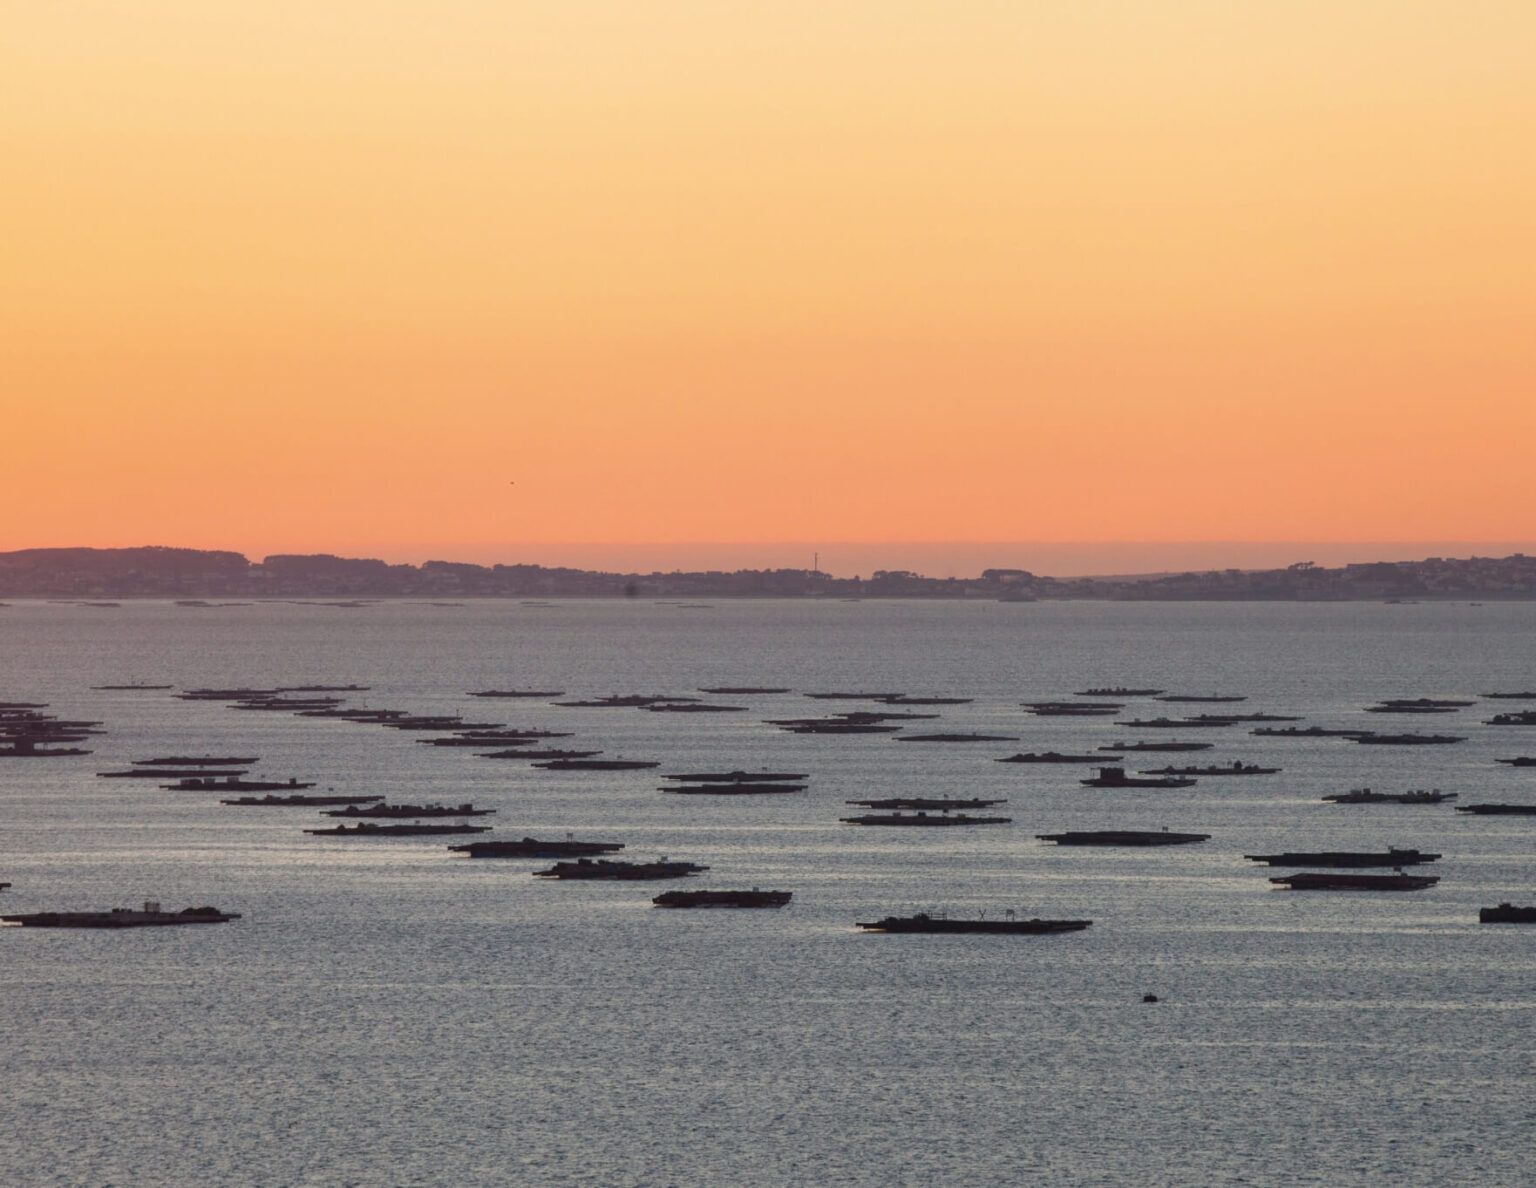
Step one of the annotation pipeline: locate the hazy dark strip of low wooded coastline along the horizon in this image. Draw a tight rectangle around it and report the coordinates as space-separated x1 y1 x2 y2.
9 546 1536 602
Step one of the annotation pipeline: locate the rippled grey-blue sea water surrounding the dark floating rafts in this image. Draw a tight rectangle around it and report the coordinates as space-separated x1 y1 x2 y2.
0 601 1536 1185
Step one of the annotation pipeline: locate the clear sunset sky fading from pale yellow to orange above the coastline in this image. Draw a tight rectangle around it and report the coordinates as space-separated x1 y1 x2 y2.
0 0 1536 555
